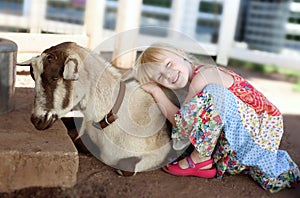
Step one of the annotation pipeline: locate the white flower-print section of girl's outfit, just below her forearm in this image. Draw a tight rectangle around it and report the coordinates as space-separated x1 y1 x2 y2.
172 90 223 155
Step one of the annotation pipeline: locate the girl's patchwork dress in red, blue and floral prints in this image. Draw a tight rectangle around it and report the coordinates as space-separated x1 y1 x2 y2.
172 67 300 192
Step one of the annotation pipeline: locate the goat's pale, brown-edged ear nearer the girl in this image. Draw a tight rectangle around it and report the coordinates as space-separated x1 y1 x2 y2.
63 55 80 80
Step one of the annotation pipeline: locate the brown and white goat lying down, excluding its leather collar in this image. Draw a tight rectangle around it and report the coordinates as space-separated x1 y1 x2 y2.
25 42 171 172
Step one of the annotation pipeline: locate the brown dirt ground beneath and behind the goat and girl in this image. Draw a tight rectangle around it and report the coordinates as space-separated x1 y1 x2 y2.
0 68 300 198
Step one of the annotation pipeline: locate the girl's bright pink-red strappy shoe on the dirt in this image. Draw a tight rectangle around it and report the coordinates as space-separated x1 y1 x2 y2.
162 156 217 178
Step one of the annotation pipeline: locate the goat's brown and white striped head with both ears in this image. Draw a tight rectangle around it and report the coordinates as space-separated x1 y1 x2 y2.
24 42 82 130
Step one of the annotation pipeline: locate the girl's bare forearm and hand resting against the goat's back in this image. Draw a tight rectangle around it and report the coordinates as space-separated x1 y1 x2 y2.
142 83 179 127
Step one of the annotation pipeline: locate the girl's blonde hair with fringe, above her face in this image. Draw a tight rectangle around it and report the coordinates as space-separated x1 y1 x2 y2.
133 43 194 84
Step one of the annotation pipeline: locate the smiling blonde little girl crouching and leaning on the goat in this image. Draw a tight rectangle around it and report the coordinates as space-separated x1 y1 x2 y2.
134 43 300 192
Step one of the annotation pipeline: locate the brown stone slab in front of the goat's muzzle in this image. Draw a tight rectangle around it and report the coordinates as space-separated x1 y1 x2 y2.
0 88 79 192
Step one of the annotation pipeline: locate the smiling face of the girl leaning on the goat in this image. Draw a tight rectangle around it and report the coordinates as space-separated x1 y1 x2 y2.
150 54 192 89
